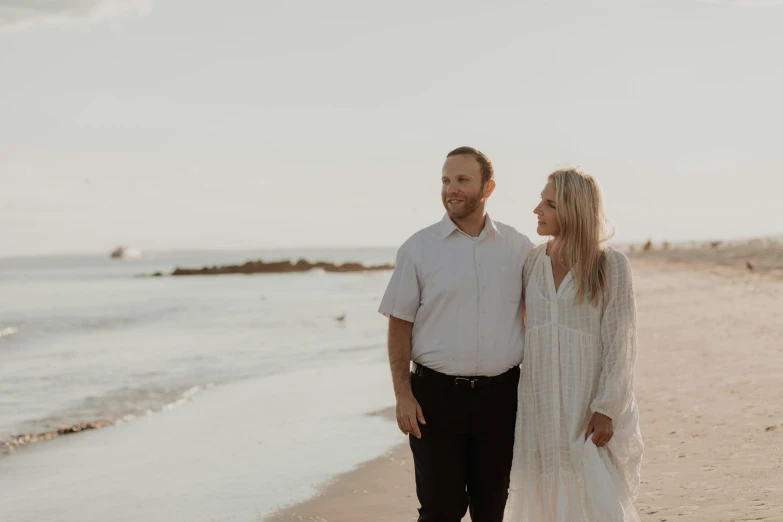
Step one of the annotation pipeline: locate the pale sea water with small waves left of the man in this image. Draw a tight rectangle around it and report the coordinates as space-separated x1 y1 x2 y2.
0 249 395 446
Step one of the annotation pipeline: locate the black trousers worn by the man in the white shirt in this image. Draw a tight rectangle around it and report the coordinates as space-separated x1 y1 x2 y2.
410 367 519 522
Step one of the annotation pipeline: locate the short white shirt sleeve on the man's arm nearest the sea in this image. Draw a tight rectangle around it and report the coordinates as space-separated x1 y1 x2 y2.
378 244 421 323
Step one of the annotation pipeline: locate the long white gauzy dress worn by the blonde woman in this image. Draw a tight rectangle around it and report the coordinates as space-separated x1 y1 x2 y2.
504 245 644 522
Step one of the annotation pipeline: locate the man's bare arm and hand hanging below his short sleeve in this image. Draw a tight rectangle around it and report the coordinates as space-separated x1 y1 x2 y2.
389 316 426 439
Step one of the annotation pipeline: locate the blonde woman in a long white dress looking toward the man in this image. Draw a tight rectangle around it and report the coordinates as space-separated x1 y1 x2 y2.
505 170 643 522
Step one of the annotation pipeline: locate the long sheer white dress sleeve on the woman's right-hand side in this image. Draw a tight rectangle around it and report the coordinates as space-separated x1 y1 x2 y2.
590 251 636 419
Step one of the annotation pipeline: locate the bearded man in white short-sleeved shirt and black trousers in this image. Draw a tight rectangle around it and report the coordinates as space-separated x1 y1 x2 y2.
379 147 533 522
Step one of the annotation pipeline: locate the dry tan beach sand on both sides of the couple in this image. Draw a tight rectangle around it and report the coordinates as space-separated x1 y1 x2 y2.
268 246 783 522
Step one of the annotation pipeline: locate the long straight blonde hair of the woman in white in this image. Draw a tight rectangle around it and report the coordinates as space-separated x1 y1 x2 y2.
548 169 614 306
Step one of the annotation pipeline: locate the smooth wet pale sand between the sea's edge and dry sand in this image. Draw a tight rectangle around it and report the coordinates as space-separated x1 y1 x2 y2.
0 362 398 522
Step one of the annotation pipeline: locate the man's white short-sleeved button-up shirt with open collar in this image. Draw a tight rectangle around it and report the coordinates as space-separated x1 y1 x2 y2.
378 214 533 376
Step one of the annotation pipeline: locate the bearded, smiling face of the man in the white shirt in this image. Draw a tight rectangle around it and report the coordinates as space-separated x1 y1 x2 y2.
440 155 488 219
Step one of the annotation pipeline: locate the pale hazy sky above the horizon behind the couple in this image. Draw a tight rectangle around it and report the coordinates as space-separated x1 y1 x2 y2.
0 0 783 256
